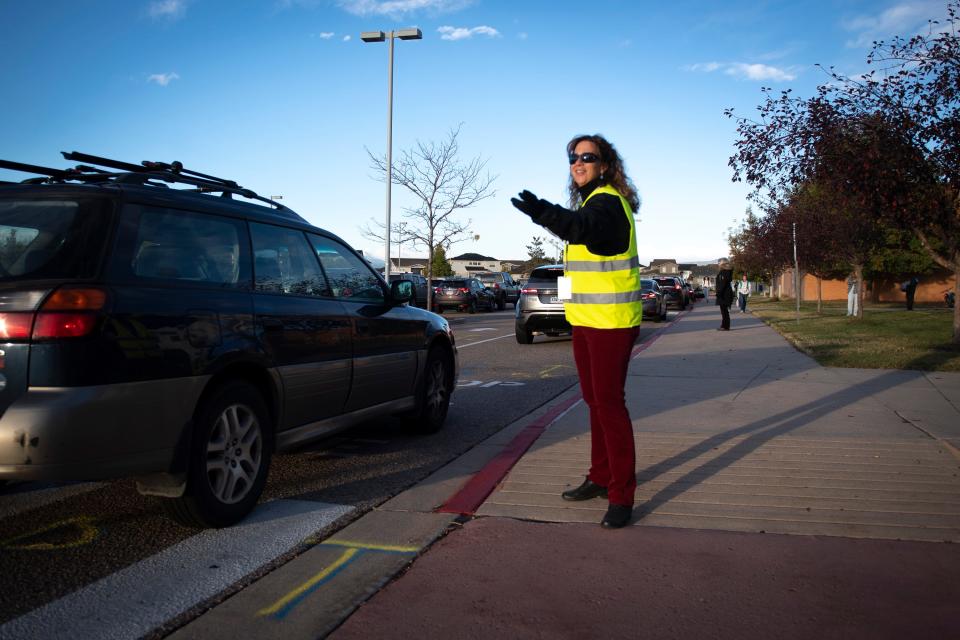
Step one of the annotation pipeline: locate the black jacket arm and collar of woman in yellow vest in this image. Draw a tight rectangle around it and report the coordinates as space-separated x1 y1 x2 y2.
533 180 630 256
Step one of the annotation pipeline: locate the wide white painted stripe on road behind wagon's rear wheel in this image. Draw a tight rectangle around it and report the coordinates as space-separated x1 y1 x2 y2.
0 500 354 640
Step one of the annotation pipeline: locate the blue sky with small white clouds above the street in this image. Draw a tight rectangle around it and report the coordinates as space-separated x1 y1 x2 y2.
0 0 946 263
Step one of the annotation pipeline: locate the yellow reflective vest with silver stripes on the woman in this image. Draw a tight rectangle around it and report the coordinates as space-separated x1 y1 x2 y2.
563 185 643 329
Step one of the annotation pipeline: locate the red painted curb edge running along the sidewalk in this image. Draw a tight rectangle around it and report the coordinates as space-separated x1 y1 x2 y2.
436 312 689 516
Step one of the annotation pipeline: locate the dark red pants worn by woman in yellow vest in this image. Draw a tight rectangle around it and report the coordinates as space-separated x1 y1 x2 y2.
573 327 640 507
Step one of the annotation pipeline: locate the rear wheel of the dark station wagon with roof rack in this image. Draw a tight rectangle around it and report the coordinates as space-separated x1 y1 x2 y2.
162 382 273 528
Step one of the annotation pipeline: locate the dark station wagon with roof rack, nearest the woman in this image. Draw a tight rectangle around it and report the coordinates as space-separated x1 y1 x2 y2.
0 152 458 527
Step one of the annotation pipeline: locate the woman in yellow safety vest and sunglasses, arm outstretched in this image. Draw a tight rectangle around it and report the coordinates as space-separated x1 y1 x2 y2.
510 135 643 529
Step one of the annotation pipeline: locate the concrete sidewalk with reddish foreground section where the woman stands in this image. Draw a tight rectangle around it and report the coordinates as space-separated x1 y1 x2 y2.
332 305 960 638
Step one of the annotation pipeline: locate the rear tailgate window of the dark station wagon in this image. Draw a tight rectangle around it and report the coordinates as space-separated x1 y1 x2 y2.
0 199 111 281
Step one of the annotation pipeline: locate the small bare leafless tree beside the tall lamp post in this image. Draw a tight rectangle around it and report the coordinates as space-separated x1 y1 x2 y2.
361 126 496 309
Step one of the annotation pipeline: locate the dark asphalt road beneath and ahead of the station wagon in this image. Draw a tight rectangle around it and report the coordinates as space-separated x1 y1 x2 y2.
0 306 657 624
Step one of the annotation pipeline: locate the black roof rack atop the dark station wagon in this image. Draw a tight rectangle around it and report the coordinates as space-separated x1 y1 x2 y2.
0 151 306 222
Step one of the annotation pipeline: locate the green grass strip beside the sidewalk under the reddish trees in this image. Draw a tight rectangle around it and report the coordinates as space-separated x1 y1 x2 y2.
748 296 960 371
